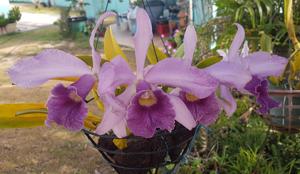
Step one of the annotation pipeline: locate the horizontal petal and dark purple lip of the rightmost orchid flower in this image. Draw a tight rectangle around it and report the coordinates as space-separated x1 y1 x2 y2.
242 42 288 114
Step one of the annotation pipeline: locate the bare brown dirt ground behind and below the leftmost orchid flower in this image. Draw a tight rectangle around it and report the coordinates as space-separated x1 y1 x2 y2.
0 24 133 174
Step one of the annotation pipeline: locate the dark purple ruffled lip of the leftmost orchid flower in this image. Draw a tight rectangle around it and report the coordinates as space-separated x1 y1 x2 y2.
46 75 96 131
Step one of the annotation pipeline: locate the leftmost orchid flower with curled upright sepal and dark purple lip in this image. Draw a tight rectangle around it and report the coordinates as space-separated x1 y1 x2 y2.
8 12 115 131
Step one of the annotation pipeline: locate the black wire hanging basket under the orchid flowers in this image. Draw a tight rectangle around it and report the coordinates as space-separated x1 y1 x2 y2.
82 124 200 174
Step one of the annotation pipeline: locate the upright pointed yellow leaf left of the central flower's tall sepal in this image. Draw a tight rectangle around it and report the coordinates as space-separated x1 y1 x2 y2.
104 27 128 61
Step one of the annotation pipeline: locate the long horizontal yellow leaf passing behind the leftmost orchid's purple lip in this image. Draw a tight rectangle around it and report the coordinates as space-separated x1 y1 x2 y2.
0 103 101 130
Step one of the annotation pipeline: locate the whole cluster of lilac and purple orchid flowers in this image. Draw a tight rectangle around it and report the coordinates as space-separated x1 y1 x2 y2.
9 9 287 138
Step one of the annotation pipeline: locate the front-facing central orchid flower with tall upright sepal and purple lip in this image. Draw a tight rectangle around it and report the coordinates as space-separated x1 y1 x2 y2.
96 9 218 138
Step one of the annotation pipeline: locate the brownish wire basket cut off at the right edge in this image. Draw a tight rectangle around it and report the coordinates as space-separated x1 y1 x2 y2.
267 90 300 133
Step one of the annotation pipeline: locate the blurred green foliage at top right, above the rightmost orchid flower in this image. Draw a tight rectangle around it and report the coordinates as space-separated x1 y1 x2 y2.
195 0 300 60
